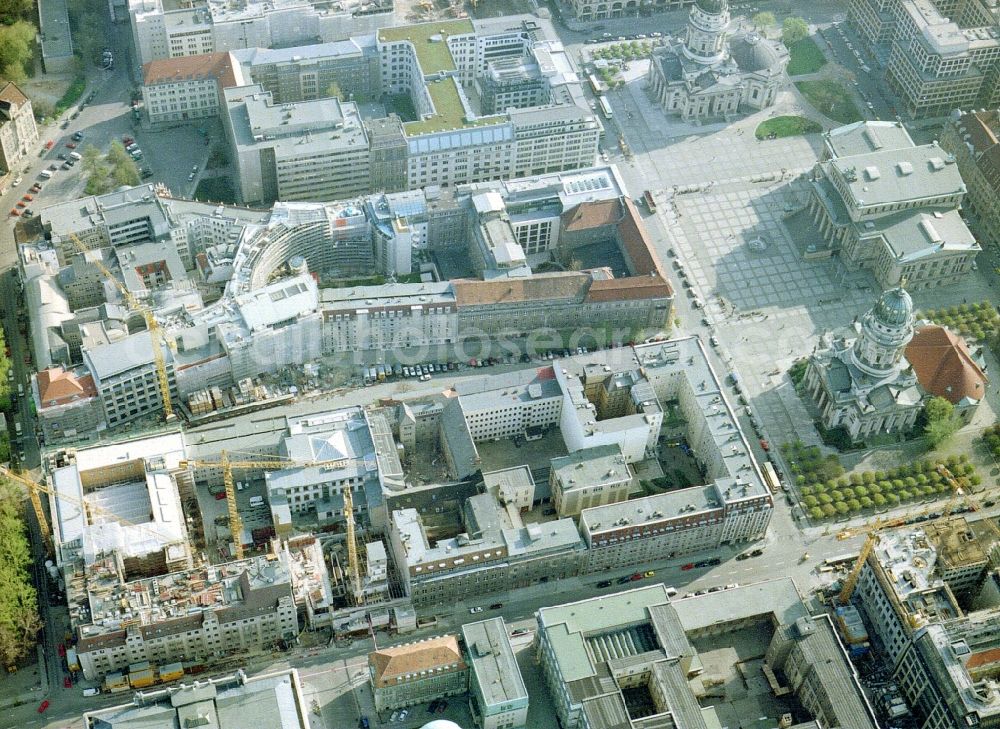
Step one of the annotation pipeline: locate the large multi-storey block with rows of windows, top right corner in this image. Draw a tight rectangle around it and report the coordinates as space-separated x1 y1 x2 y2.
848 0 1000 118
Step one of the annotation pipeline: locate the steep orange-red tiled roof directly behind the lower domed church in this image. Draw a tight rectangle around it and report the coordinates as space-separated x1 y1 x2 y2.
906 325 987 403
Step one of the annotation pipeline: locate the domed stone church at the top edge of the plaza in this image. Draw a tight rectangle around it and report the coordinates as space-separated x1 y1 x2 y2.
647 0 788 121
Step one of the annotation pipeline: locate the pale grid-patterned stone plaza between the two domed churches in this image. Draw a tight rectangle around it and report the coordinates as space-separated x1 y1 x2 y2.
605 71 991 464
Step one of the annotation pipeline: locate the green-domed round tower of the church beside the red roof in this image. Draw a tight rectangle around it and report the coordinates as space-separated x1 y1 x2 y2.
851 286 913 379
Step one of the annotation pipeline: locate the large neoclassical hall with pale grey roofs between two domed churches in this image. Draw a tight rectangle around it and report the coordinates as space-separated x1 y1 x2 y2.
806 122 980 290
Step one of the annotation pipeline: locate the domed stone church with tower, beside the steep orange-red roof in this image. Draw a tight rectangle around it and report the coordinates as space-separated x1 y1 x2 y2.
805 287 924 441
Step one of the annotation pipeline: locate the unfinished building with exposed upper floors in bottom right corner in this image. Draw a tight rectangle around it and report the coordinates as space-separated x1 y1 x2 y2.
855 520 1000 729
